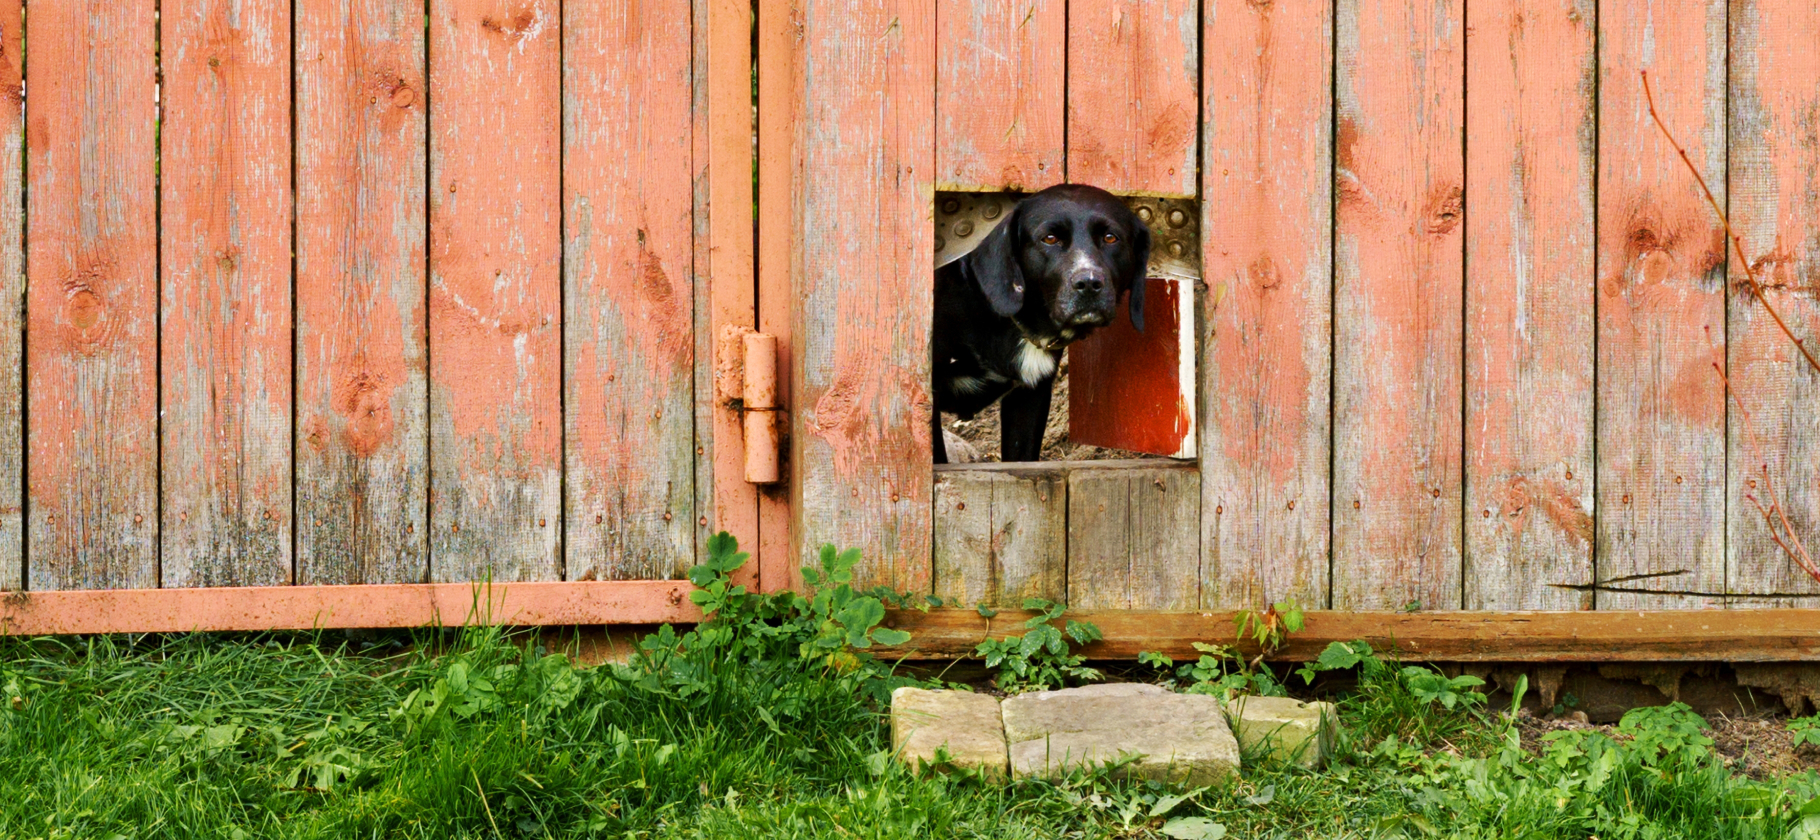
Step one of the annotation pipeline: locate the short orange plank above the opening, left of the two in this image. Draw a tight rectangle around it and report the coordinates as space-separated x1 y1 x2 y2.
935 0 1068 191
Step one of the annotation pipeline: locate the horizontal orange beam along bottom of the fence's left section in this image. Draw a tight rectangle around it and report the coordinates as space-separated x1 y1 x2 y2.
0 580 701 636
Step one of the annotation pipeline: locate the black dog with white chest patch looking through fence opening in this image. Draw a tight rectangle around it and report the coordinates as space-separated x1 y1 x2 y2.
932 184 1150 464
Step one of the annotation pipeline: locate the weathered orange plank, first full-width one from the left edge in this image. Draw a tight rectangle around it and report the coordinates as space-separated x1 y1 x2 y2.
25 0 158 589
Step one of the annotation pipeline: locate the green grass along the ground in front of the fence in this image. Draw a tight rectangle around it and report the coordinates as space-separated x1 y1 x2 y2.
0 631 1815 840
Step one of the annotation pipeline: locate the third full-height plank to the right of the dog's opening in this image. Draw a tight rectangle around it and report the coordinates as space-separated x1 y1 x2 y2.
1465 0 1598 609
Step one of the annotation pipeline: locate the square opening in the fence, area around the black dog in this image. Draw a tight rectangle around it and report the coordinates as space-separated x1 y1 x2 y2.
934 193 1201 464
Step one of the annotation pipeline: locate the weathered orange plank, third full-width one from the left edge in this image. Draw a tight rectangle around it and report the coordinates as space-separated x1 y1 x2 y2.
295 0 430 584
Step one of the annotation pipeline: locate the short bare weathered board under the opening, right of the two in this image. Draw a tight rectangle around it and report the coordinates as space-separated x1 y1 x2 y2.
1068 462 1201 609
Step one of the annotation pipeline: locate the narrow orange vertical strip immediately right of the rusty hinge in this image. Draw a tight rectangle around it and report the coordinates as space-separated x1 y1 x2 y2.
757 0 806 591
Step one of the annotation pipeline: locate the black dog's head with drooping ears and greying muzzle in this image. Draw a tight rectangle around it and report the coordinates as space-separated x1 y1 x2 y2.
966 184 1150 333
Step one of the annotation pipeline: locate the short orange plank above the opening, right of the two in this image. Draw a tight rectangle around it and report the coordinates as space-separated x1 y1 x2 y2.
1068 0 1201 196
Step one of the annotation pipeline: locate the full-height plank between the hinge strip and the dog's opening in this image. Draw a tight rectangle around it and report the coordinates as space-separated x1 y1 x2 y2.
790 0 935 593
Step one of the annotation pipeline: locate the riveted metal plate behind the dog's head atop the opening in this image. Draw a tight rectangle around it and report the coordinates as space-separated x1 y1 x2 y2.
935 193 1201 280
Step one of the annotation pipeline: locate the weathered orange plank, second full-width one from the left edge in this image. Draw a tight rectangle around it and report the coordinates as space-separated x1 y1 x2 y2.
158 0 291 587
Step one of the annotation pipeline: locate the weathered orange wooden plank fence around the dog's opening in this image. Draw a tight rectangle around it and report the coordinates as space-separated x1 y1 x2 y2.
0 0 1820 631
